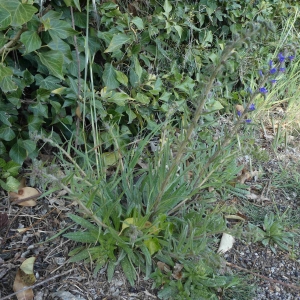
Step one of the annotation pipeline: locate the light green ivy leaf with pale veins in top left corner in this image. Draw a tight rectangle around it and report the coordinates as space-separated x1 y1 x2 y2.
0 0 38 27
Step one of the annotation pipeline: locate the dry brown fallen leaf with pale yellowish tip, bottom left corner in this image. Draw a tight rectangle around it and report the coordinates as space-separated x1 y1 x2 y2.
13 257 36 300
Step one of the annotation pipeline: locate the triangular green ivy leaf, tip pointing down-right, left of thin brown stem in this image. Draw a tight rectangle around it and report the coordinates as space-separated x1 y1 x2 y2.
38 50 64 80
